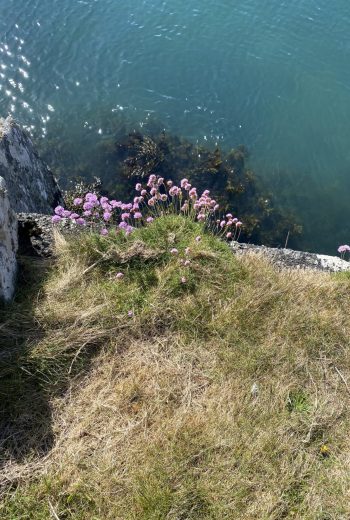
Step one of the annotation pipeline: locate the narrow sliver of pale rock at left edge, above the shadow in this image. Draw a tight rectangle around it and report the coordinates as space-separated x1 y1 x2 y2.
0 177 18 300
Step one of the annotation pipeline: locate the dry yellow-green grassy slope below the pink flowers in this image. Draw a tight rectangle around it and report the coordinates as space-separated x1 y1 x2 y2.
0 216 350 520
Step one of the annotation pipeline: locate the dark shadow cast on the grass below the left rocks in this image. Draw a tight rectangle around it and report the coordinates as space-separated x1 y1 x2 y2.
0 257 53 485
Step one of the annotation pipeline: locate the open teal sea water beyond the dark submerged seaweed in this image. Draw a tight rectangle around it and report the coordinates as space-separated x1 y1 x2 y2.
0 0 350 252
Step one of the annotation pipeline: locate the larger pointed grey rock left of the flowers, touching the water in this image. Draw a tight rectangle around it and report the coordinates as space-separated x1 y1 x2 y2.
0 117 62 214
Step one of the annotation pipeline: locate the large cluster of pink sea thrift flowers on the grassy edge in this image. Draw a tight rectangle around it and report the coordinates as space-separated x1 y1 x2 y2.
52 174 242 240
